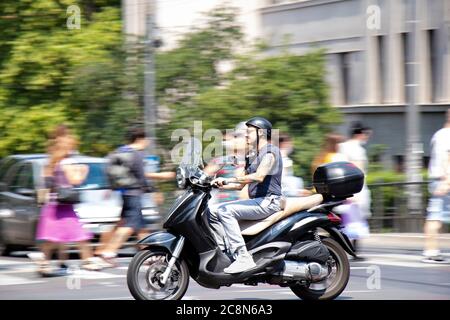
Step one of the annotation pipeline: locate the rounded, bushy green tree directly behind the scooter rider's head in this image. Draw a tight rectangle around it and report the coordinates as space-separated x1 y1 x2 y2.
189 51 340 180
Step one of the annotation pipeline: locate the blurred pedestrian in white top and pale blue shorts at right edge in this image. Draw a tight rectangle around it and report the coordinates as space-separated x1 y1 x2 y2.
423 109 450 263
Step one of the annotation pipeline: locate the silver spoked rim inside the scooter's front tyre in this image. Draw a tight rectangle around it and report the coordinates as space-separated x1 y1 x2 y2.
136 252 182 300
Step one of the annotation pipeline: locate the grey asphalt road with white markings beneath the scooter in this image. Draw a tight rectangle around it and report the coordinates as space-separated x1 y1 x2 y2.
0 248 450 300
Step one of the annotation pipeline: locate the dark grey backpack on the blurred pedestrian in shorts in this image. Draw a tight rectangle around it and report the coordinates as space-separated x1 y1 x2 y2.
106 149 142 190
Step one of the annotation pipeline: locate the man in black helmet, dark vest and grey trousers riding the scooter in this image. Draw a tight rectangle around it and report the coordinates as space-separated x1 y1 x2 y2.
209 117 283 274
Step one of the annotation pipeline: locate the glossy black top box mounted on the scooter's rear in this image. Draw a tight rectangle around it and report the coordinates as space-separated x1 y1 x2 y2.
313 161 364 198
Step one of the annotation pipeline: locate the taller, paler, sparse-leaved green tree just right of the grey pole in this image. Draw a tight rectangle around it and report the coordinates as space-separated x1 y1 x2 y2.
156 6 243 146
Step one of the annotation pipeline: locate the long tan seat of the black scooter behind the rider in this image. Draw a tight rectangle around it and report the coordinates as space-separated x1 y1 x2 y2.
239 194 323 236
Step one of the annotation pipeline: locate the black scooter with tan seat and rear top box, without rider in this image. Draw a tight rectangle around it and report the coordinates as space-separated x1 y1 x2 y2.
127 142 364 300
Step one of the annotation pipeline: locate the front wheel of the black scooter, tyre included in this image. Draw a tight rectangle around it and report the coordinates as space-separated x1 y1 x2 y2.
127 249 189 300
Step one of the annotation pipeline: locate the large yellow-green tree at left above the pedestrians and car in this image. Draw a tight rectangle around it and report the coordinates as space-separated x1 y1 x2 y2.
0 0 140 156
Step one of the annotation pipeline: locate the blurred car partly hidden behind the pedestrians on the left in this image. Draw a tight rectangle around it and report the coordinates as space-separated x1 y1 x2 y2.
0 154 161 254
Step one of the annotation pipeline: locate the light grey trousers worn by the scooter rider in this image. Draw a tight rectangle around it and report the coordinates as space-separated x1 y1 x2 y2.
208 196 281 254
